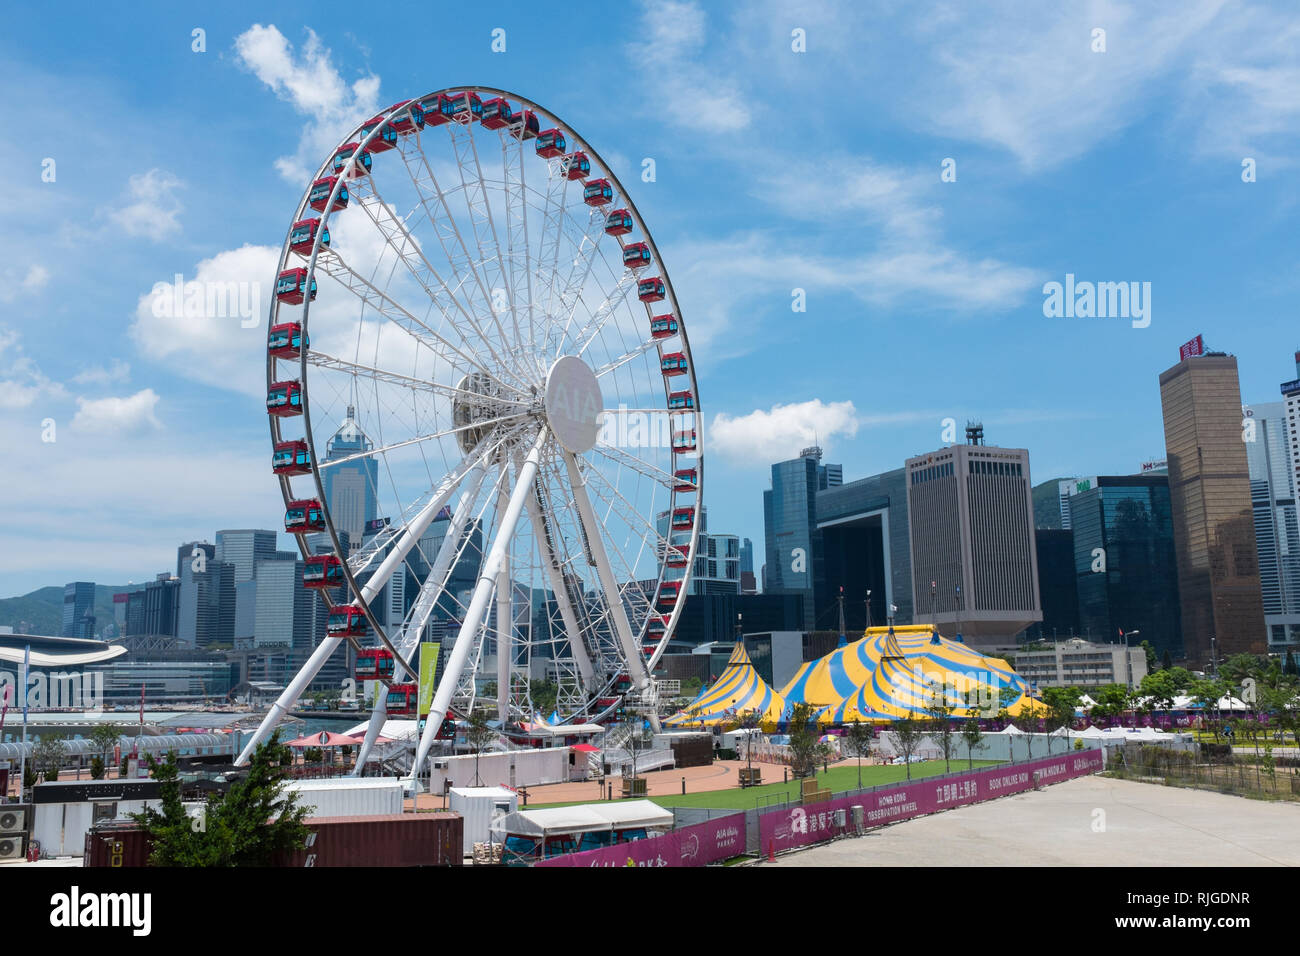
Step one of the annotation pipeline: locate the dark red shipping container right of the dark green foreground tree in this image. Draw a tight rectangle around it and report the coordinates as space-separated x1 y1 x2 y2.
274 813 464 866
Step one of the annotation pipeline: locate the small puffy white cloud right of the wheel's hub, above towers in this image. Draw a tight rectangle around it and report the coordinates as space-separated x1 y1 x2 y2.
706 398 859 463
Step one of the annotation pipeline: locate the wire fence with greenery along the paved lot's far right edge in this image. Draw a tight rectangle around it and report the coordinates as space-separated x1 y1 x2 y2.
1109 744 1300 800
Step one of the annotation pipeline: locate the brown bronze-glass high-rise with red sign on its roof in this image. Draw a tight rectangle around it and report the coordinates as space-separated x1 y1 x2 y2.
1160 354 1268 669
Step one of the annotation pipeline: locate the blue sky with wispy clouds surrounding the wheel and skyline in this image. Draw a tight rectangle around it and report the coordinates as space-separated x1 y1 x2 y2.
0 0 1300 596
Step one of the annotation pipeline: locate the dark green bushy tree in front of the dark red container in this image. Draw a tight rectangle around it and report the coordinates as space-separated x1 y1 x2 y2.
131 731 315 866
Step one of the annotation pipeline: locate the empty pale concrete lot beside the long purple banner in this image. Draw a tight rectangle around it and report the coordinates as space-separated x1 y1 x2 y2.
761 777 1300 866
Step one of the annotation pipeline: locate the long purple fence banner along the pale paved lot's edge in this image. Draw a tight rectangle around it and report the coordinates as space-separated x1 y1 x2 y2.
758 749 1101 853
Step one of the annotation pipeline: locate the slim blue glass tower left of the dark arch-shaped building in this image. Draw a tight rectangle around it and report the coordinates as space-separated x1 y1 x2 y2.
763 446 844 631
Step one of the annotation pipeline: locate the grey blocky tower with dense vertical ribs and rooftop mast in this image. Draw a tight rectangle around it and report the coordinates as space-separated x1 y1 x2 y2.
904 425 1043 646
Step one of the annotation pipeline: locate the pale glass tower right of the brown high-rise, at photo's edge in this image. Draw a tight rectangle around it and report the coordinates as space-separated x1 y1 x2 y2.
1244 402 1300 652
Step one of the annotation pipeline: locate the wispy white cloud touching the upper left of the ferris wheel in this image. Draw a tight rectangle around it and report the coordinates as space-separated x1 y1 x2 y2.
235 23 380 185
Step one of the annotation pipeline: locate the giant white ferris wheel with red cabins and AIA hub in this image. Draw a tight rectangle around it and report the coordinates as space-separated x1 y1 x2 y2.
239 87 703 777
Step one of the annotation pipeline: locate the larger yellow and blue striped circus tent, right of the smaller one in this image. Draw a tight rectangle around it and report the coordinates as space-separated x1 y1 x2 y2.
781 626 1041 724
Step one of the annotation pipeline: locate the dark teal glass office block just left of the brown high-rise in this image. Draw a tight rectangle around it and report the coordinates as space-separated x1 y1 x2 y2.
1060 473 1184 659
